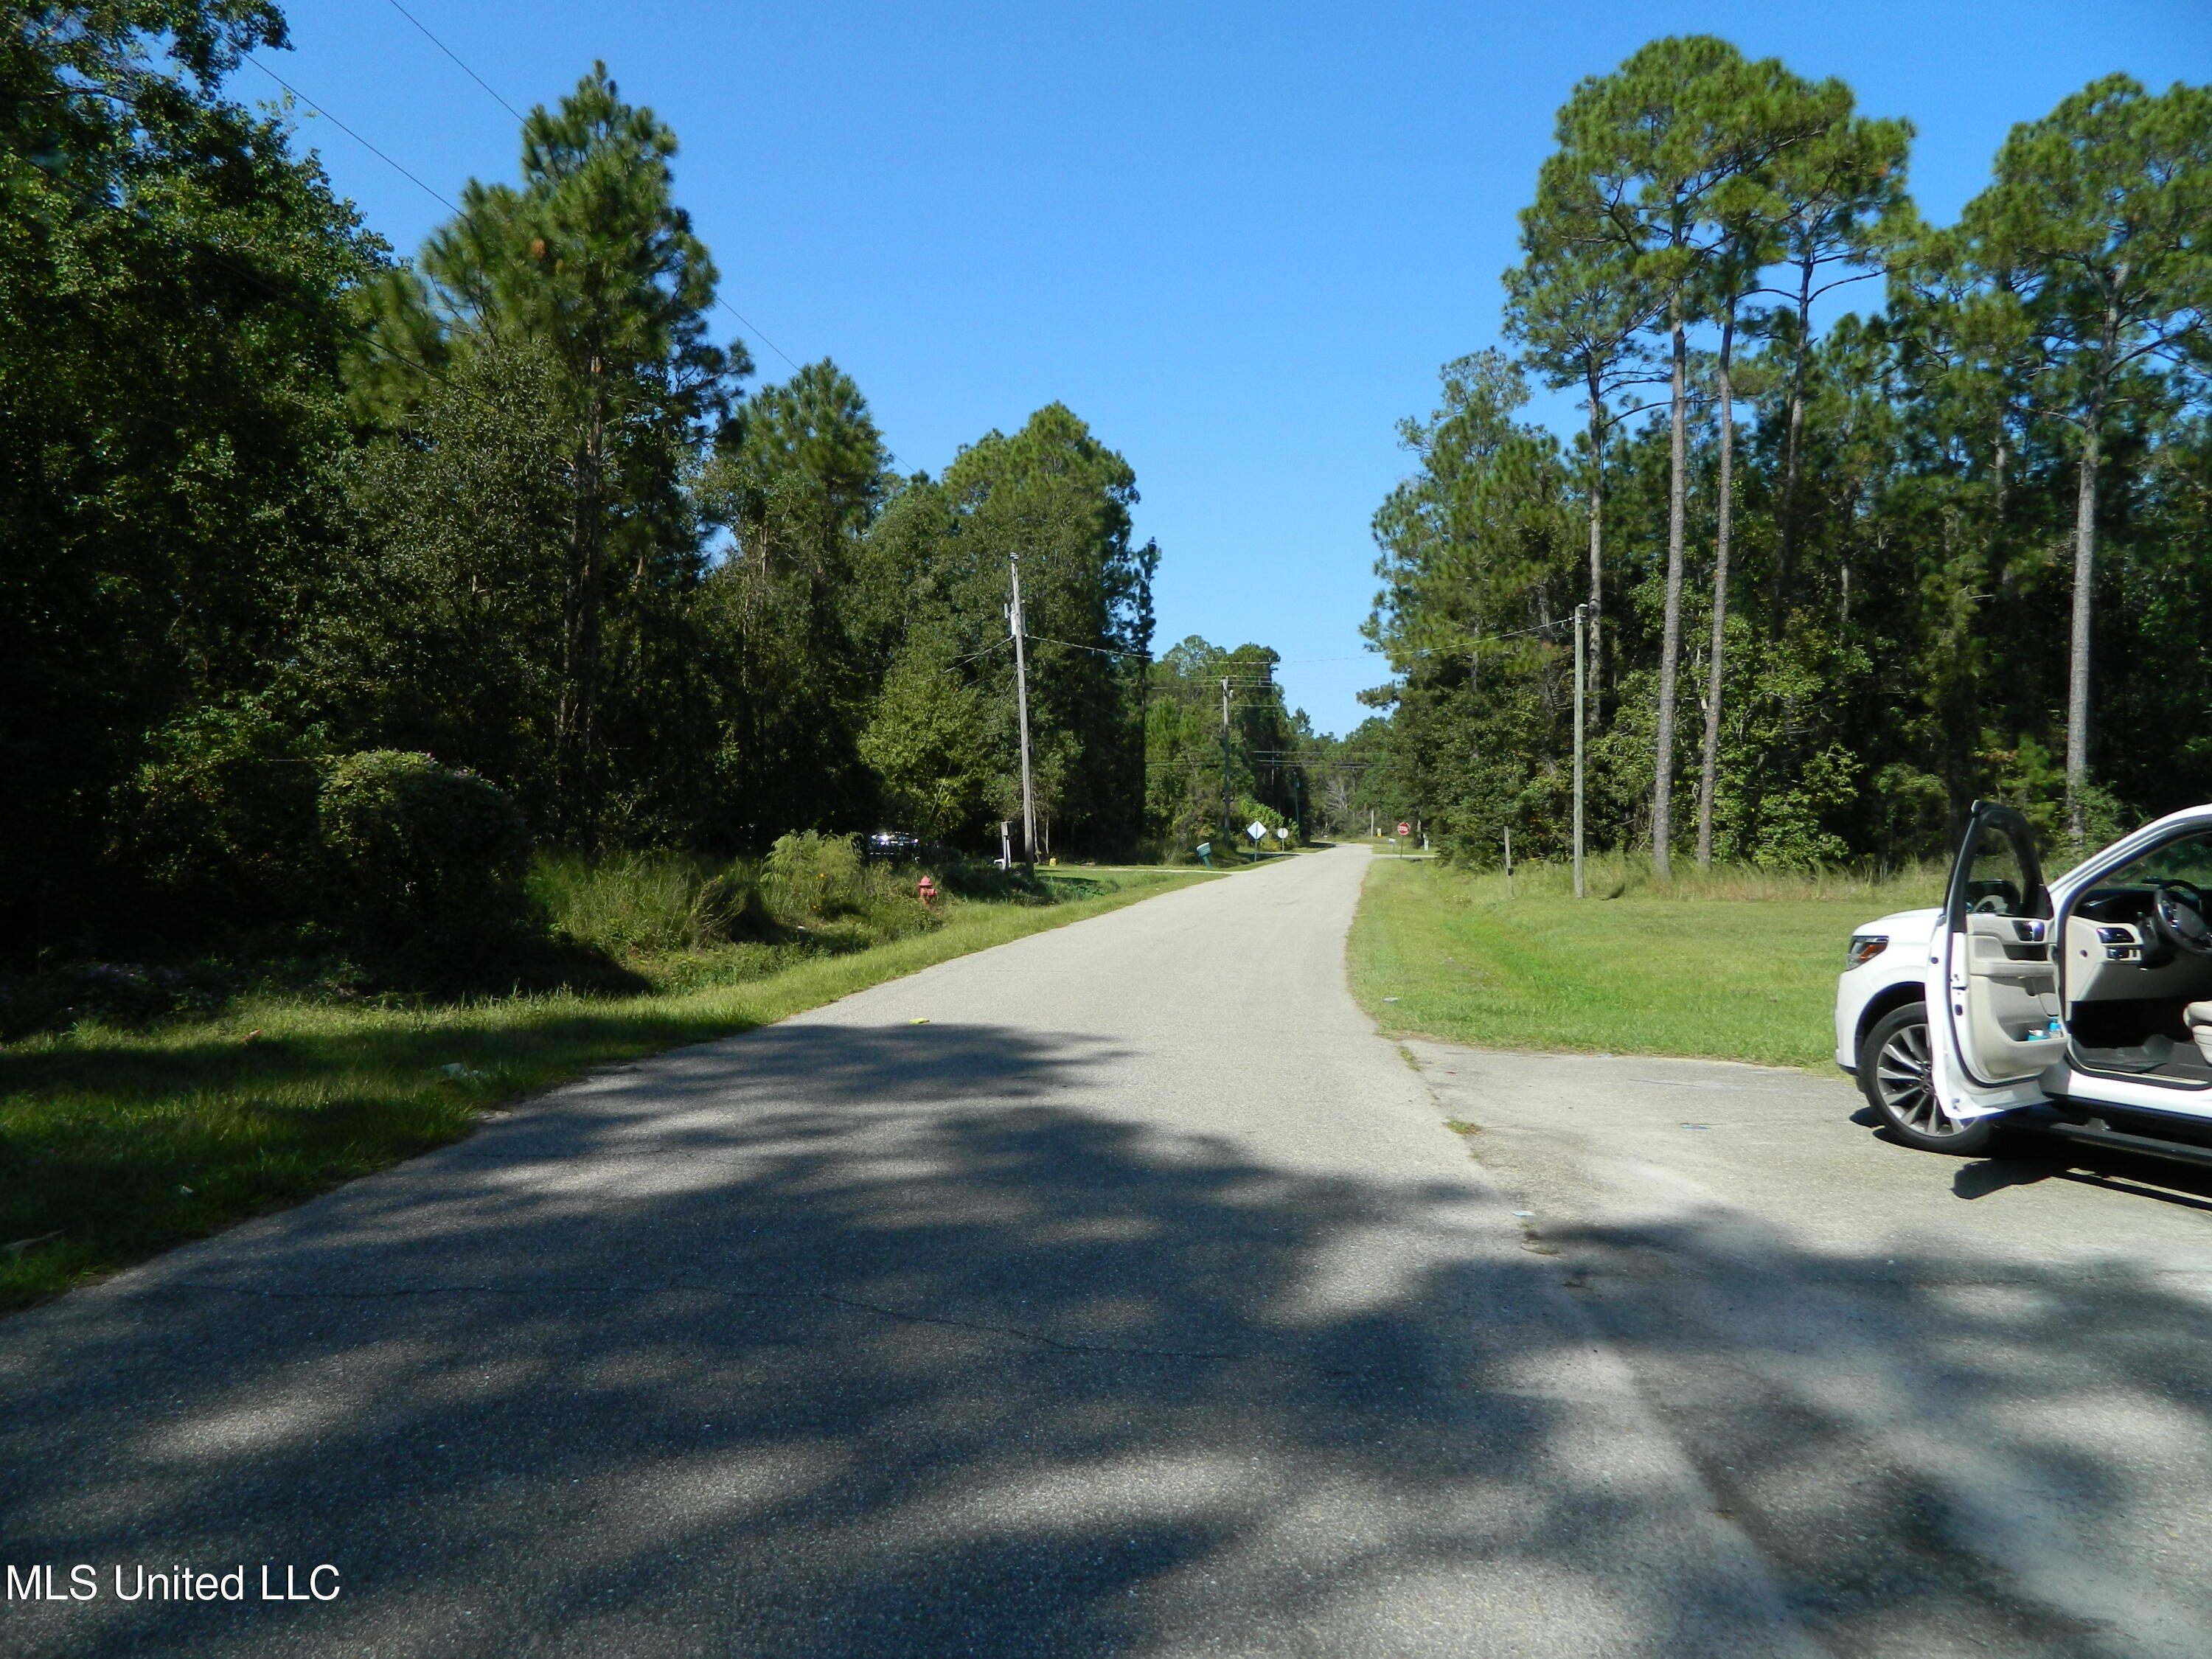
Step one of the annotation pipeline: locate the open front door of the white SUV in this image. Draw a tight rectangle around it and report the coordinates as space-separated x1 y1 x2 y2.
1929 801 2066 1119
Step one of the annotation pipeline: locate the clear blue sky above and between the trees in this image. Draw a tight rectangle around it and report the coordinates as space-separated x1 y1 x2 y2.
251 0 2212 730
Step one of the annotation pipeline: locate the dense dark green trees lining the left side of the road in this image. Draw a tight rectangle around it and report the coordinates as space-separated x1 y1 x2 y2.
0 0 1161 960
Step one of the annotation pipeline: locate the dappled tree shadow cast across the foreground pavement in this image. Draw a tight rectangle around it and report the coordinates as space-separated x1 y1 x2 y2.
0 1024 2205 1659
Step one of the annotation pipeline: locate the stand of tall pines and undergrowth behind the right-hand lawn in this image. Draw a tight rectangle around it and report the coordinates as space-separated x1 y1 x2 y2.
1360 38 2212 869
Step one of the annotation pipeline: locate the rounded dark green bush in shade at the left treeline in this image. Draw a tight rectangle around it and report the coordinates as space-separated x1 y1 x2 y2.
319 750 529 953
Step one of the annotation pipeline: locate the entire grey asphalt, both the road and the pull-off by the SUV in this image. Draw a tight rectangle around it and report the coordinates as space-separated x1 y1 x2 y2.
0 849 2212 1659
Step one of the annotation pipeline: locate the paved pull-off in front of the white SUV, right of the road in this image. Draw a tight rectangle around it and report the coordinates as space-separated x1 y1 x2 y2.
1411 1042 2212 1659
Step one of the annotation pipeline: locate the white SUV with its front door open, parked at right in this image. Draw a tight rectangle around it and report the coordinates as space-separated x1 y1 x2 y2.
1836 801 2212 1164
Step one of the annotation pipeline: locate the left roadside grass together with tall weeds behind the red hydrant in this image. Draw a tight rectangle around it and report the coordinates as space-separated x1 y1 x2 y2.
0 854 1206 1310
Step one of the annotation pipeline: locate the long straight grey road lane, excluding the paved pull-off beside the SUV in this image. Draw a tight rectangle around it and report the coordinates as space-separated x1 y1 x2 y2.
0 849 1807 1659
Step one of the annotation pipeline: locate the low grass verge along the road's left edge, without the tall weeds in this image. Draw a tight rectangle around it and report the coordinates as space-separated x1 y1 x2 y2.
0 869 1208 1310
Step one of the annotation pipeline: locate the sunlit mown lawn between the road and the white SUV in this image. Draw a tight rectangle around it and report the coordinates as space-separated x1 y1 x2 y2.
1352 858 1938 1071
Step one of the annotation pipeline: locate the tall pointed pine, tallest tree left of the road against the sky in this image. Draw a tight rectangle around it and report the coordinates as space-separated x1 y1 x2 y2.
356 64 752 843
